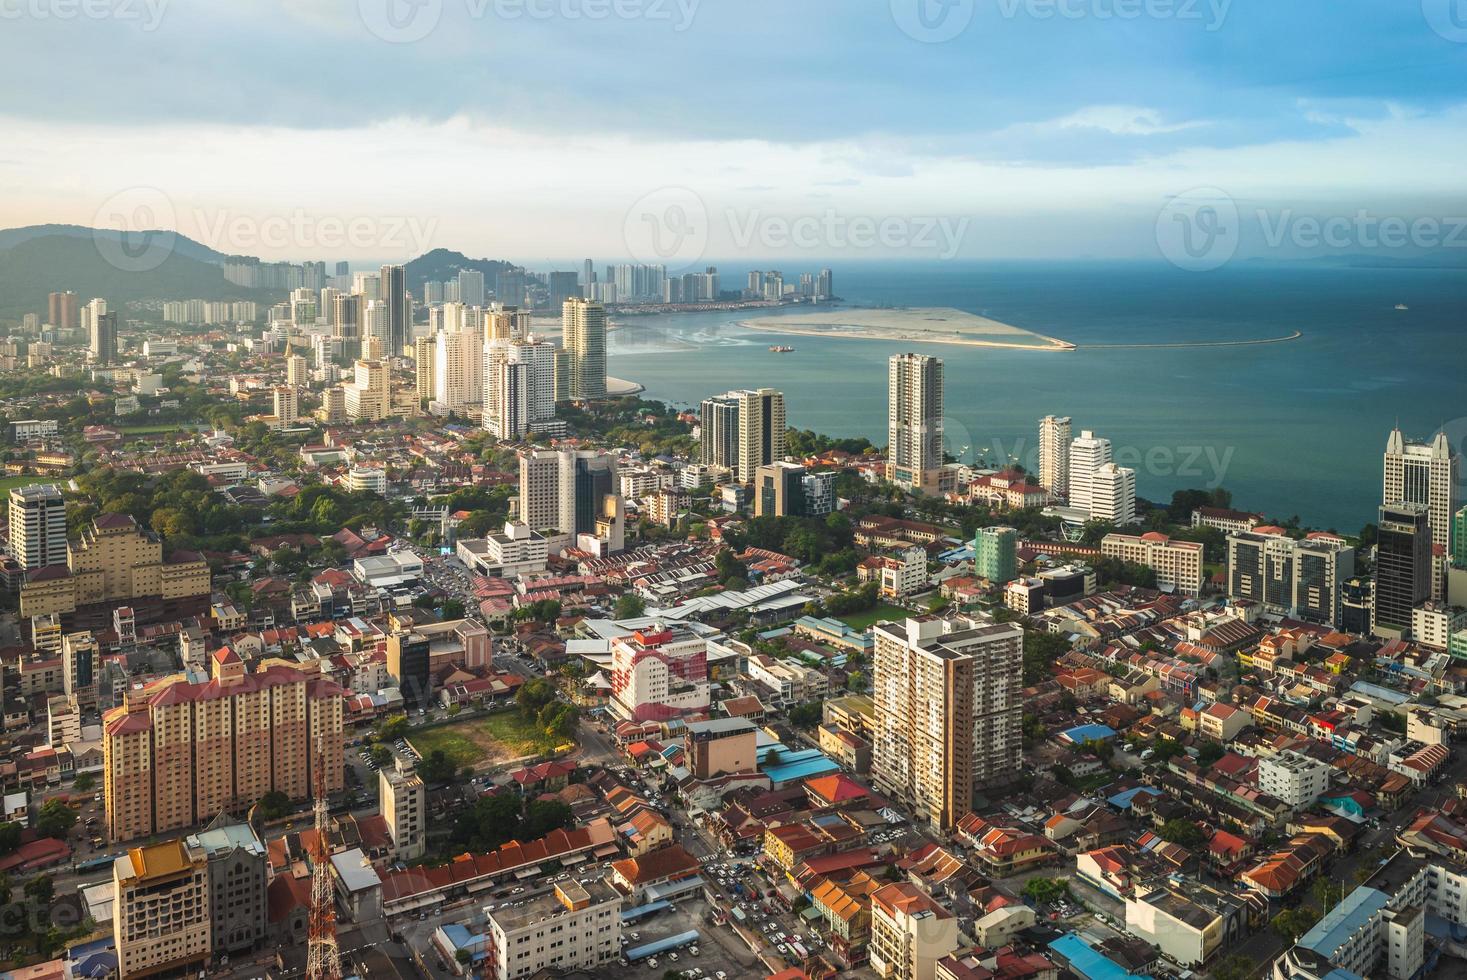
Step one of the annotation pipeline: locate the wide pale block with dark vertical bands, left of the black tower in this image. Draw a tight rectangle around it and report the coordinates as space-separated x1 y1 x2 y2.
1228 528 1349 632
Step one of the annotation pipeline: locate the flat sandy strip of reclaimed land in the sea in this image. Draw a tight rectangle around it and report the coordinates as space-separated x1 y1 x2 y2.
741 307 1075 351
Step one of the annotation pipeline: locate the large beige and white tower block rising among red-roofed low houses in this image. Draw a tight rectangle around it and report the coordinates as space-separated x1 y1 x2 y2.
871 618 1024 830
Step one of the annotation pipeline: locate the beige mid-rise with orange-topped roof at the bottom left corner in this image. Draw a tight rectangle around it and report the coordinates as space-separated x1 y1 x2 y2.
111 841 211 980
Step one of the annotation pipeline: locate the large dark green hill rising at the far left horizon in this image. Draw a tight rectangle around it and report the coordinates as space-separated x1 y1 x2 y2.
0 235 270 320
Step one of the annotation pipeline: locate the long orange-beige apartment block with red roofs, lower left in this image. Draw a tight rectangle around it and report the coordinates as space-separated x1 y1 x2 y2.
103 647 343 841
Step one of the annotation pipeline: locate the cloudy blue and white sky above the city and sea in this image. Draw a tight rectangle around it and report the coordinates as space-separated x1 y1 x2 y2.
0 0 1467 270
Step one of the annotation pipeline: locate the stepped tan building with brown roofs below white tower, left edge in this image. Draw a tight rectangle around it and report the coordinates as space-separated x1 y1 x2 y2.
21 513 210 616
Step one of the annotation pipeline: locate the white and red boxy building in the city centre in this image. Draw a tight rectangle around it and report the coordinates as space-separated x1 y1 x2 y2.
610 625 710 722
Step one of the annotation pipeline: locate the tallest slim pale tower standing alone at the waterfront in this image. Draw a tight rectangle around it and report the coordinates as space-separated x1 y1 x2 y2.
886 354 943 493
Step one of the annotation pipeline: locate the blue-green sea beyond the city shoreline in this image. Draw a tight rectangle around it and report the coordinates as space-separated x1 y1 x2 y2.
609 261 1467 533
